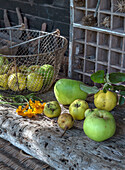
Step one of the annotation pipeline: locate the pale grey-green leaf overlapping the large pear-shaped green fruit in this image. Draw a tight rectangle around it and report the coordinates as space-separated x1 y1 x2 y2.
80 84 99 94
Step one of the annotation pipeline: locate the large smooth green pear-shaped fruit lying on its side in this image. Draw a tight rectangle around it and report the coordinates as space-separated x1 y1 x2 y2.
54 79 87 105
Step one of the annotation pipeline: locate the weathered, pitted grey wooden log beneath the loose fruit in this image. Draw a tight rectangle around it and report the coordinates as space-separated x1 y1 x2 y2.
0 106 125 170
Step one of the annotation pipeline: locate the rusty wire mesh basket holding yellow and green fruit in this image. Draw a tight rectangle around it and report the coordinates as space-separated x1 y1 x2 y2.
0 26 67 94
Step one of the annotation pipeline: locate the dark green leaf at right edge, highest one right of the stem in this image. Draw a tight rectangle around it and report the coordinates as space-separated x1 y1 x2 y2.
109 73 125 83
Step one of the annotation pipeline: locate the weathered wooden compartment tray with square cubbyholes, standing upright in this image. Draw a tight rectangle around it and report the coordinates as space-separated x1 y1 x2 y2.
68 0 125 85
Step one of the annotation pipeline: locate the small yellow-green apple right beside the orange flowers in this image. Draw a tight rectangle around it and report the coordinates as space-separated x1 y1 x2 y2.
44 101 61 118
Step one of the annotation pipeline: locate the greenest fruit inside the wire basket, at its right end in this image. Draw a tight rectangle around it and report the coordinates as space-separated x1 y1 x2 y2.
38 64 54 86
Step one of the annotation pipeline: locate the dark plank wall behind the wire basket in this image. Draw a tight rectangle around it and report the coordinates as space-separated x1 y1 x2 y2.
0 0 70 38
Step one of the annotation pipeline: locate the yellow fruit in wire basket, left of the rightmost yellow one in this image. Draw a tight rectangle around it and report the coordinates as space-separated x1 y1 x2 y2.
8 73 26 91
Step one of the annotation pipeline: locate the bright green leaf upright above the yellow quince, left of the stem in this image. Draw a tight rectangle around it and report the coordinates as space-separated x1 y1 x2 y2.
91 70 105 83
